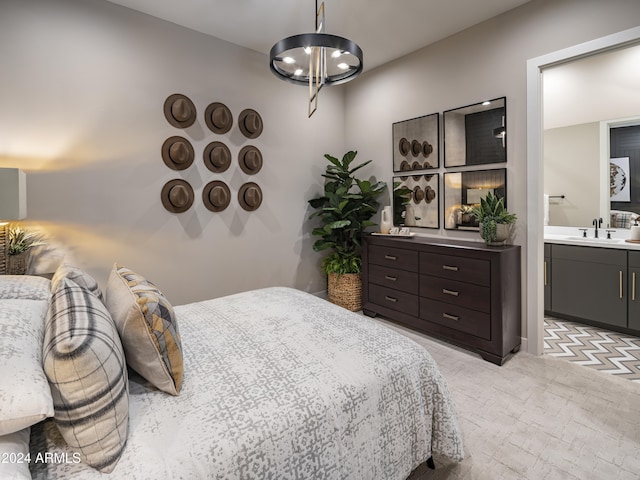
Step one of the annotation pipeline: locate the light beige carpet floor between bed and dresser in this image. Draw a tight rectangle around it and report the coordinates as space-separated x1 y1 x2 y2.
376 318 640 480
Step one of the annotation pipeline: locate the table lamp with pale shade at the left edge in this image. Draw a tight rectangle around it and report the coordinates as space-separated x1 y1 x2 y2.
0 168 27 275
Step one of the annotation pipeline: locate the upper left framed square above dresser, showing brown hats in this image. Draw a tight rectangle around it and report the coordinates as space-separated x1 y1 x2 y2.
392 113 440 173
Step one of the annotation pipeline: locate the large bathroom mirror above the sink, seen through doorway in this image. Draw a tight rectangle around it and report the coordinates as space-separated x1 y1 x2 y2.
542 44 640 228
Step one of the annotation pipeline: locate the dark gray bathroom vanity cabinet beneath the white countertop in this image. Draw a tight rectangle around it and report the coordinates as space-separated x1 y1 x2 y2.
545 244 640 331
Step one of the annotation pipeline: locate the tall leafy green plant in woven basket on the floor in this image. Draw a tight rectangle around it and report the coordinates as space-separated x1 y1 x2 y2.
309 151 386 311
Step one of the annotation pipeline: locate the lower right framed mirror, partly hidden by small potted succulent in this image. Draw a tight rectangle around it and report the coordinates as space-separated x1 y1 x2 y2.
443 168 507 231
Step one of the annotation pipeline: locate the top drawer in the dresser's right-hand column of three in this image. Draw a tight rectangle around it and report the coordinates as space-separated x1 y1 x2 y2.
420 252 491 286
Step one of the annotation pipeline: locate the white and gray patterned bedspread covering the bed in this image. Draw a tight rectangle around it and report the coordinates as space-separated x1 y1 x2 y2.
31 287 463 480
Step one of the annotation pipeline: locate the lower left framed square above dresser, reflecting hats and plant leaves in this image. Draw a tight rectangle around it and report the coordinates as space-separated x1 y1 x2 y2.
393 173 440 228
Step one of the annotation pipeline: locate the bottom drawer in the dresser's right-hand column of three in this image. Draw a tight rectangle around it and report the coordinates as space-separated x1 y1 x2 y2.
420 298 491 340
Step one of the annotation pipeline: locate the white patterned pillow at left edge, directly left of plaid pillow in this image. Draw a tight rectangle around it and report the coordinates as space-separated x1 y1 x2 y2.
0 300 53 435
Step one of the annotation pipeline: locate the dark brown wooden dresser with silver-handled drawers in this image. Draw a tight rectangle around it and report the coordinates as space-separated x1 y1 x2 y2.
362 235 521 365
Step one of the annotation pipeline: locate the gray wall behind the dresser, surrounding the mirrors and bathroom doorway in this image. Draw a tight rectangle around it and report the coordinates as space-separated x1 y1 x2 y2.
346 0 640 344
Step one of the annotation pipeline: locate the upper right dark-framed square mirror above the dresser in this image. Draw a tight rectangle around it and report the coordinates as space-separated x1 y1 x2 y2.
443 97 507 167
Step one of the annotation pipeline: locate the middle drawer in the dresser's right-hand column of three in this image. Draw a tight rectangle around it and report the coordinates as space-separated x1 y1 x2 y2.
420 275 491 313
